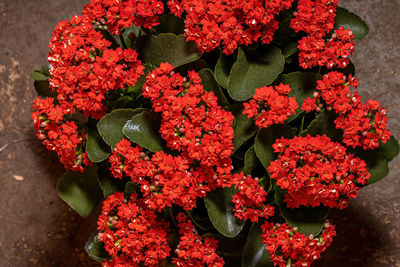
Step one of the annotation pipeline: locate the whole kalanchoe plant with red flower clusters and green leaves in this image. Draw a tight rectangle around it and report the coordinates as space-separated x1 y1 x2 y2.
32 0 399 267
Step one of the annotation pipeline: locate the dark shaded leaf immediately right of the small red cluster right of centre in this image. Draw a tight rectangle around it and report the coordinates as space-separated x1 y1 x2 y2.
276 72 322 120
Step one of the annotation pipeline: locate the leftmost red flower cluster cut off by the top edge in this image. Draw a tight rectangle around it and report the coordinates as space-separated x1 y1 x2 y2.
82 0 164 35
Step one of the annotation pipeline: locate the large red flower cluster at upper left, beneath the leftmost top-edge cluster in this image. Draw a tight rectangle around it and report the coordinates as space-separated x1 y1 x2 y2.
48 16 144 119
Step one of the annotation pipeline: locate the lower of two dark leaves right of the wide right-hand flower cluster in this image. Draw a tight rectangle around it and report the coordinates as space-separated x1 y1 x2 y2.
349 148 389 184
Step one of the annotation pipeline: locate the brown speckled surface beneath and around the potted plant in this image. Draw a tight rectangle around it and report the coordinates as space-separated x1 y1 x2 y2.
0 0 400 267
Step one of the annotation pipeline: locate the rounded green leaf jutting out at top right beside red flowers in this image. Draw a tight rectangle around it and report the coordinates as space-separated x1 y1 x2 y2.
335 7 369 40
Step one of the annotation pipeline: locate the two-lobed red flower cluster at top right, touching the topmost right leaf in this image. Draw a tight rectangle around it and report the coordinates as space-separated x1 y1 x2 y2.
290 0 355 69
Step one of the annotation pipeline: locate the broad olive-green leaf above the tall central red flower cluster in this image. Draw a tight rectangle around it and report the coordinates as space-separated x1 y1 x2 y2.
139 33 202 67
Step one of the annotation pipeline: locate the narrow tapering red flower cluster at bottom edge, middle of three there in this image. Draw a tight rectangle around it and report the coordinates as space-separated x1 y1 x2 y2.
172 212 225 267
